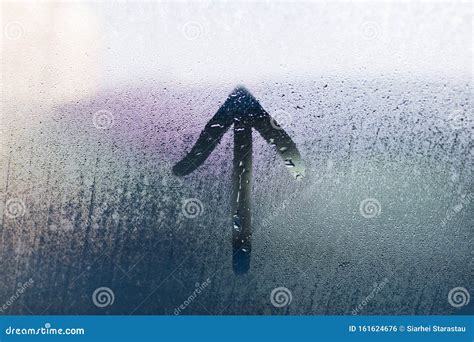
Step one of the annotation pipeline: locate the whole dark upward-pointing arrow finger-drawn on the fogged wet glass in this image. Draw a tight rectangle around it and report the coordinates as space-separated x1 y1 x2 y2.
173 86 305 273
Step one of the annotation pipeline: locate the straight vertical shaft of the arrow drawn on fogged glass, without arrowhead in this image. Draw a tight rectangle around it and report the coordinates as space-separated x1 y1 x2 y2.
232 121 252 272
